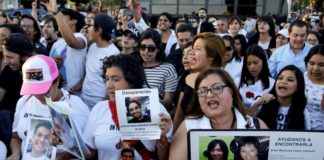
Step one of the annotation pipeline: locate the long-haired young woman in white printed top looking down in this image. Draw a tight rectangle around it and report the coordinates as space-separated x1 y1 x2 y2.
236 44 274 115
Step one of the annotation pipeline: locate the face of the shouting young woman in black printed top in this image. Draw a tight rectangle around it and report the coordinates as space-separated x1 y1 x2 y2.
276 70 297 98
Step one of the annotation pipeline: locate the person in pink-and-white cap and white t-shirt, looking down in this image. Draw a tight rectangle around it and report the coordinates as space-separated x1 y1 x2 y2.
8 55 90 160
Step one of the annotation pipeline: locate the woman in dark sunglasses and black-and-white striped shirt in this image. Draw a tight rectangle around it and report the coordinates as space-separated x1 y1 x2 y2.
140 28 178 112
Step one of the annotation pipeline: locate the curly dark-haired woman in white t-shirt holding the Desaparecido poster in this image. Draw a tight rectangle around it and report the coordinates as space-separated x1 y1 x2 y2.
84 55 172 160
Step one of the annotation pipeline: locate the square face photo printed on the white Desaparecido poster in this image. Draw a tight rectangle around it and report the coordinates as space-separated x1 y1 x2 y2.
125 96 151 123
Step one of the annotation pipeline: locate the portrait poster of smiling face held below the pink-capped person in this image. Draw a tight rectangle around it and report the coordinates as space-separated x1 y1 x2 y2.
22 118 56 160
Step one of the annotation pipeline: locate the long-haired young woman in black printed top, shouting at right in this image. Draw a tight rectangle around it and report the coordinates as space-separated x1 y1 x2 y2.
258 65 310 130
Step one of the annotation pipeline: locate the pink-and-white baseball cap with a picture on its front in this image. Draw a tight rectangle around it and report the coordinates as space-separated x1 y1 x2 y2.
20 55 59 95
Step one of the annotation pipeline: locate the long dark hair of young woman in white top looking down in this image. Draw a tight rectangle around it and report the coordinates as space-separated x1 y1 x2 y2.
239 44 271 89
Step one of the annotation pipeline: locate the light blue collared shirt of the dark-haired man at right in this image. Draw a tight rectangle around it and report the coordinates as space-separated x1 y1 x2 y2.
268 43 313 77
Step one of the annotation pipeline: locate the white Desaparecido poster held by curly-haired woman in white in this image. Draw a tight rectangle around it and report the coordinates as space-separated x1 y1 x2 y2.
116 88 161 140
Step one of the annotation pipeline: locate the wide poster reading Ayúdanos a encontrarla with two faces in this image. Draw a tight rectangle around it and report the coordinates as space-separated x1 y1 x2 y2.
188 130 324 160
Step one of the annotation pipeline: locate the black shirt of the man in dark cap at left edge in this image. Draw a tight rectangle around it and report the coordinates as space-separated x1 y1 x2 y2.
0 65 23 111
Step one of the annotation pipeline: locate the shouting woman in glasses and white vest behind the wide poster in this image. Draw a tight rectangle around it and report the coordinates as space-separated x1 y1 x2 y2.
170 68 267 160
